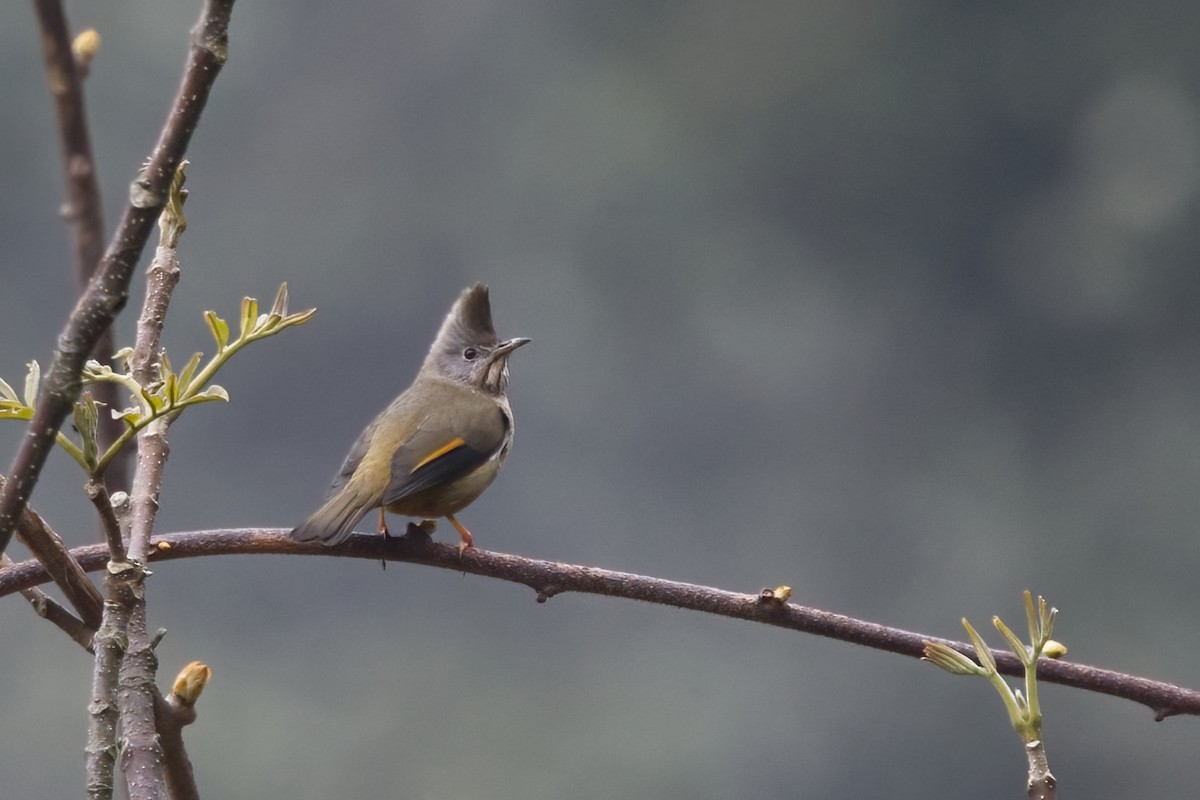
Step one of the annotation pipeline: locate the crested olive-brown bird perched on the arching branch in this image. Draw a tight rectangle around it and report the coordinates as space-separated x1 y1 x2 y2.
292 283 529 548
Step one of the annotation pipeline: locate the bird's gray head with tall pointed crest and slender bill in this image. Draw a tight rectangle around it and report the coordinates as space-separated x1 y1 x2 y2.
421 283 529 395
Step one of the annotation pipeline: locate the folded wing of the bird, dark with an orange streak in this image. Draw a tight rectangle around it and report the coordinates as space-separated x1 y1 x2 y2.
383 397 511 506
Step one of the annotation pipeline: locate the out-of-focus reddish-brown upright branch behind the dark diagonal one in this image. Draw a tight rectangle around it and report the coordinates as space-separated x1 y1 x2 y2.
34 0 128 488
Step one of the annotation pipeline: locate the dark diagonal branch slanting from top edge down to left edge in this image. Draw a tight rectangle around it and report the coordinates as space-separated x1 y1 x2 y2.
0 0 234 563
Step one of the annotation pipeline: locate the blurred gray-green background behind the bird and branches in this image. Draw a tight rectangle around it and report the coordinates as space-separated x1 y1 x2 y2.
0 0 1200 800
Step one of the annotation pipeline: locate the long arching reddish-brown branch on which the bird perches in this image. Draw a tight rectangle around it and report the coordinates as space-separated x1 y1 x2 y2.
0 528 1200 720
